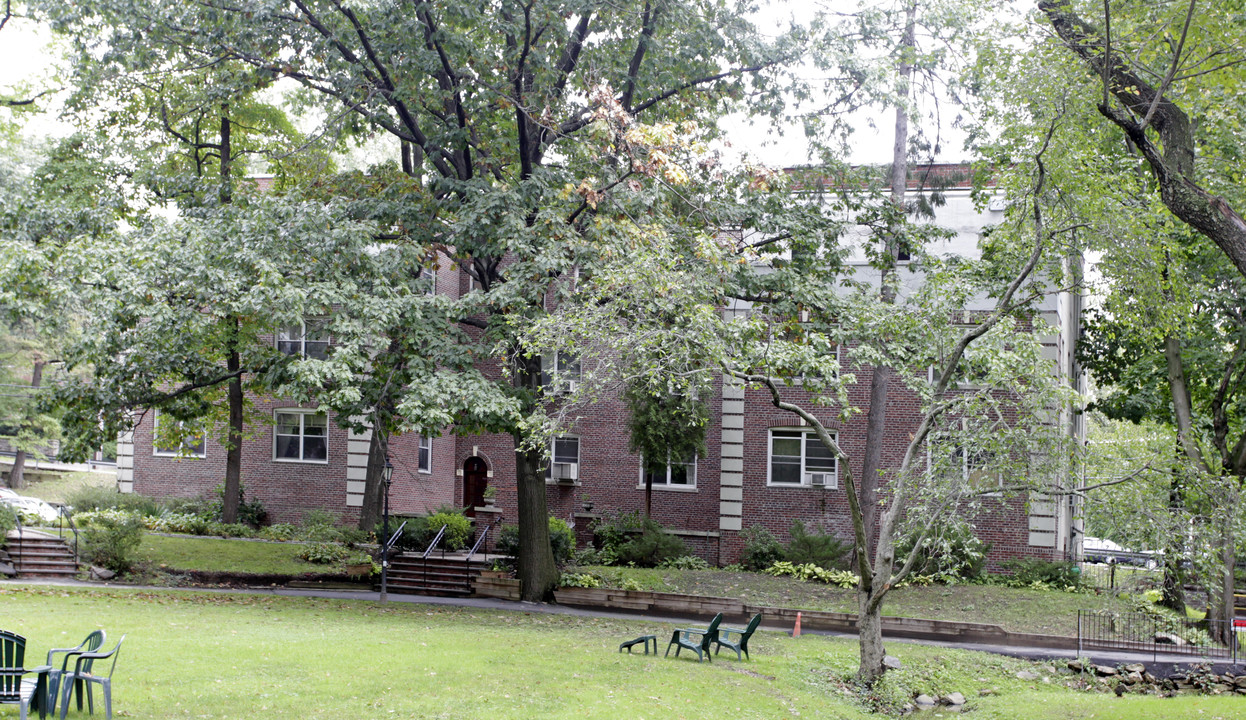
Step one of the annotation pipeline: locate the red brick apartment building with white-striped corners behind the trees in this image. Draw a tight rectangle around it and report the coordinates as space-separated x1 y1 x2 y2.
117 166 1082 564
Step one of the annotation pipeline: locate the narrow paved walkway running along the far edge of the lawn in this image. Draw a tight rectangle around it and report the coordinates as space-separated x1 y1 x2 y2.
0 578 1232 676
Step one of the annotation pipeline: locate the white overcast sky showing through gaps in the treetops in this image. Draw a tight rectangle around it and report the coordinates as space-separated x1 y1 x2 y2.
0 0 966 167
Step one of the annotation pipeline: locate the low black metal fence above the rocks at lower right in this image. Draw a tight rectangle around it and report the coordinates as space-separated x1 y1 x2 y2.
1078 610 1246 664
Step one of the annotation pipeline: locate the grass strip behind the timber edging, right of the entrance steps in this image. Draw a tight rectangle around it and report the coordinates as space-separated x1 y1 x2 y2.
579 567 1129 635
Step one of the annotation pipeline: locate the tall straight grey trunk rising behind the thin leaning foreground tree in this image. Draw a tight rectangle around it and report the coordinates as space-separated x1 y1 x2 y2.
856 0 917 557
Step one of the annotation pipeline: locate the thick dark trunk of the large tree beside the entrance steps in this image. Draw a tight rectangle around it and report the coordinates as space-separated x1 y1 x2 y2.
512 358 558 602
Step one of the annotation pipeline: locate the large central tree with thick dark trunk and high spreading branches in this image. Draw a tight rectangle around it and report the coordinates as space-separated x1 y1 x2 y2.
38 0 794 599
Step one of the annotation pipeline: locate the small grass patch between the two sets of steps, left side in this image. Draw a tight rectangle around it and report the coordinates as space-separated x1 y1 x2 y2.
136 534 339 576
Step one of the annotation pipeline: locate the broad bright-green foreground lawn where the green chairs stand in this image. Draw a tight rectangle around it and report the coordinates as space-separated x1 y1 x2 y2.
0 585 1240 720
